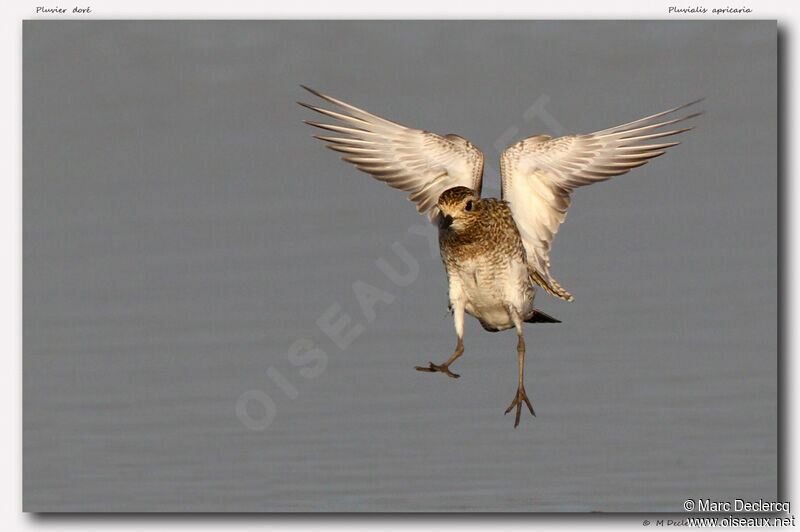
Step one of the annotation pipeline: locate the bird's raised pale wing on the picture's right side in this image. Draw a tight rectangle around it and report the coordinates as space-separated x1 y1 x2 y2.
500 100 701 301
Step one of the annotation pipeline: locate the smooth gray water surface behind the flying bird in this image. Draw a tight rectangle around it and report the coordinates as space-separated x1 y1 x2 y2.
23 21 778 512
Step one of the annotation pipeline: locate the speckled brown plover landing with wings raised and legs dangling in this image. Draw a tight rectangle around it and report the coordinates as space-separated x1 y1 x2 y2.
297 85 703 428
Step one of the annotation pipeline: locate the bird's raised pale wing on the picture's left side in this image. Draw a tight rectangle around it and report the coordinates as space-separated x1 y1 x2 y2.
298 85 483 221
